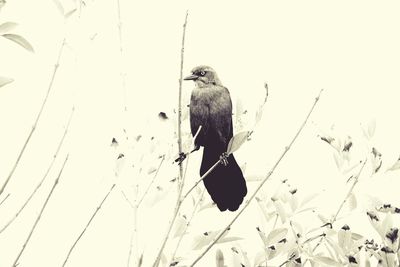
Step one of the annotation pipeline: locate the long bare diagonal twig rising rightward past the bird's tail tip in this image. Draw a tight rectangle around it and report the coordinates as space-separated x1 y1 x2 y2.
190 90 323 266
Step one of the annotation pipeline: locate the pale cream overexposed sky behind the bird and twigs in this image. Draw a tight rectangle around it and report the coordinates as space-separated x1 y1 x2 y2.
0 0 400 266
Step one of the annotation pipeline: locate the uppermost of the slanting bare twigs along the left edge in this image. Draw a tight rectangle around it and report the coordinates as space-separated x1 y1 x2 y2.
0 39 65 195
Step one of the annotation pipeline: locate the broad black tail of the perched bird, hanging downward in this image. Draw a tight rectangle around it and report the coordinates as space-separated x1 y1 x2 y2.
200 146 247 211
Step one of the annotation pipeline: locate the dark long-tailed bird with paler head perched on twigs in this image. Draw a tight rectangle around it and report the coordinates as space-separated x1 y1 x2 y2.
185 66 247 211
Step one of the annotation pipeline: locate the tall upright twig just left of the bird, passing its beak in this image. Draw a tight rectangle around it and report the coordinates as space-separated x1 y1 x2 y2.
153 11 188 267
